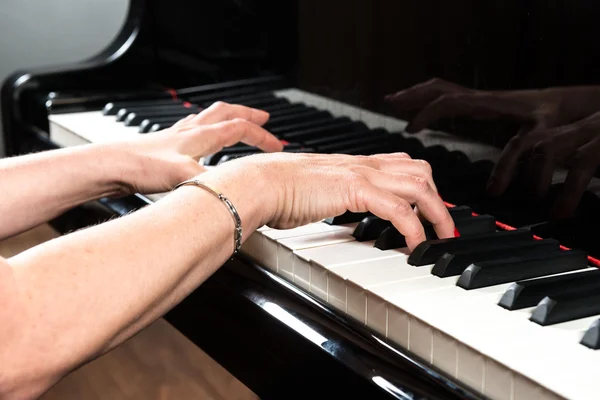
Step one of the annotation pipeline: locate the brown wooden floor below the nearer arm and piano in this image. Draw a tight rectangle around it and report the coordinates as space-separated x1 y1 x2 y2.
0 225 258 400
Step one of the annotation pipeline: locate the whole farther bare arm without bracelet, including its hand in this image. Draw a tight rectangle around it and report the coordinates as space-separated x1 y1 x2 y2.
0 103 282 238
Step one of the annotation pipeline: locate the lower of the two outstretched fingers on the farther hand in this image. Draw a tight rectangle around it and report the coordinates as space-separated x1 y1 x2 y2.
190 119 283 155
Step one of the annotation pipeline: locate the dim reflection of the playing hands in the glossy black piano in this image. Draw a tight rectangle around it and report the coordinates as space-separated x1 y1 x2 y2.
386 79 600 216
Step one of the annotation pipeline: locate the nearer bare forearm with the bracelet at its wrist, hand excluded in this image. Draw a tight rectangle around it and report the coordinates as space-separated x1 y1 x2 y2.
0 179 260 397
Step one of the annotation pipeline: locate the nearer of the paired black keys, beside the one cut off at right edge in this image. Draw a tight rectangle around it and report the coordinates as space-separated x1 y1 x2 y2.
530 285 600 326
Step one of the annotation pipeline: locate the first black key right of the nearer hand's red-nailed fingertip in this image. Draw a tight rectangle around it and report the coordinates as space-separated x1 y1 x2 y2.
408 229 535 266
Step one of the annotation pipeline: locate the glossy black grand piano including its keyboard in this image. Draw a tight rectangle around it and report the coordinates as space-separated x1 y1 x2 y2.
2 0 600 400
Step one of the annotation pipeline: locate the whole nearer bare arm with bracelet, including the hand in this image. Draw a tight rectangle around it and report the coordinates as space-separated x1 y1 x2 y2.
0 154 454 398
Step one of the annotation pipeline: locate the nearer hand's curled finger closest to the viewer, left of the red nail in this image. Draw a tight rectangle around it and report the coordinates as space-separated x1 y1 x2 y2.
351 183 426 251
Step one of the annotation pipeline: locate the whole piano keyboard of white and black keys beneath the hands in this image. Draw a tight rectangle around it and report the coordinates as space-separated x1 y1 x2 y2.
49 82 600 400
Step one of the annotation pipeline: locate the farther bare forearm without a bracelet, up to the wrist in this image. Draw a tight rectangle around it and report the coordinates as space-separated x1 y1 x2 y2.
0 145 132 238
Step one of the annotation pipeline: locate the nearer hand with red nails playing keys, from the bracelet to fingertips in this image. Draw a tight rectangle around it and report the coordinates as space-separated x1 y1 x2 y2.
198 153 455 251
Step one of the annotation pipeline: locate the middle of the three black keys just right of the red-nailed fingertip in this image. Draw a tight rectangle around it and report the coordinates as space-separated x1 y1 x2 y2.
431 239 560 278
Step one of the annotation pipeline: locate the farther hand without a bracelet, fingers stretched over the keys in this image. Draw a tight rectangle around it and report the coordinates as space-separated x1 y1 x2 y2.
105 102 283 195
